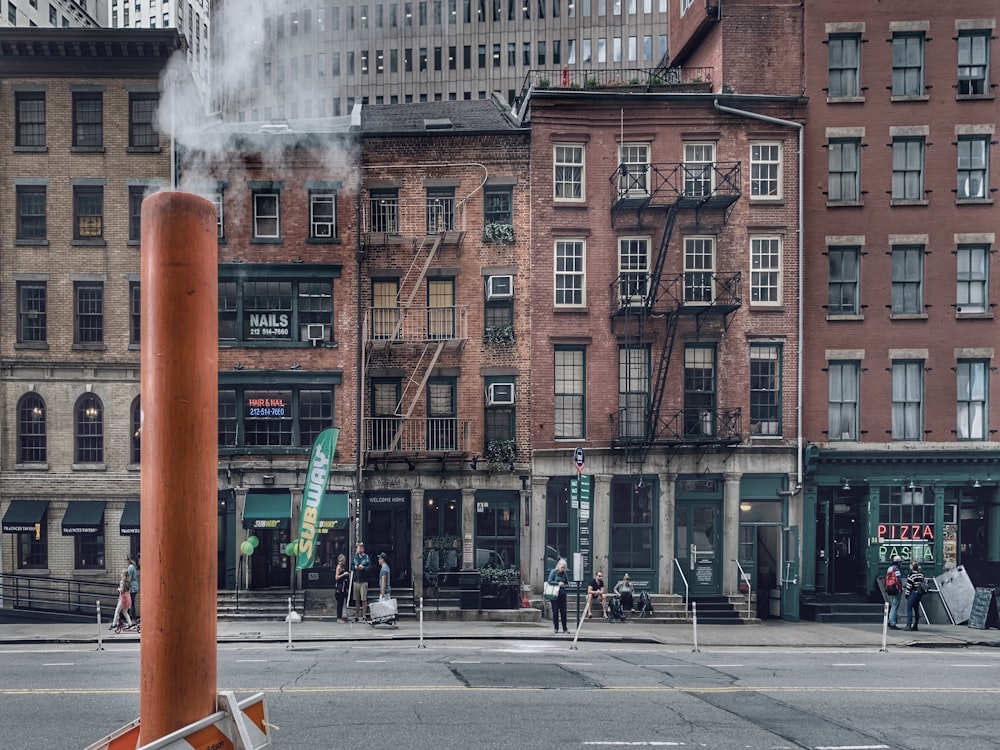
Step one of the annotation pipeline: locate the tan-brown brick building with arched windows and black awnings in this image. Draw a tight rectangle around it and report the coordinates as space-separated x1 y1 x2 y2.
0 28 181 581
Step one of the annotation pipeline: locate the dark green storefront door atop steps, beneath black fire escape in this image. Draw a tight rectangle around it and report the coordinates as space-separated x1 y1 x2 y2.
674 500 722 596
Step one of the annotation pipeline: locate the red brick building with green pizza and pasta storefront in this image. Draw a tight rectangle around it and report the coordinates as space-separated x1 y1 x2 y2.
800 0 1000 593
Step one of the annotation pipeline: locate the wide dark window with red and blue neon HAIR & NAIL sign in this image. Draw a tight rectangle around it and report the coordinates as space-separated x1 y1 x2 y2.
219 382 333 451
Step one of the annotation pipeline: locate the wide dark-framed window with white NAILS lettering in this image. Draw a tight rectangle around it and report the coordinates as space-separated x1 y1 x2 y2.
219 278 333 345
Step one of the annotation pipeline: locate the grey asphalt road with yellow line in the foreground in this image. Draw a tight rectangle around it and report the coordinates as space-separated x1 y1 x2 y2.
0 640 1000 750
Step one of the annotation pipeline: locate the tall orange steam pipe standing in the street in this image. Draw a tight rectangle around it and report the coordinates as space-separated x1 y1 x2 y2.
139 192 219 745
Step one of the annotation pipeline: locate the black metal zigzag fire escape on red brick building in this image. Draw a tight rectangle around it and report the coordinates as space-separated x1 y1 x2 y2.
609 162 742 476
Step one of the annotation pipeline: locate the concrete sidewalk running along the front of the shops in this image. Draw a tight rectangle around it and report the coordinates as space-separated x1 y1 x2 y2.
7 618 1000 650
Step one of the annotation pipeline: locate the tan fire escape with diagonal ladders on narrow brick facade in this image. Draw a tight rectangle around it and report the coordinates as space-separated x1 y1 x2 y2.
362 188 469 470
